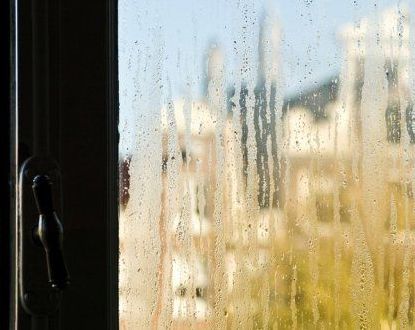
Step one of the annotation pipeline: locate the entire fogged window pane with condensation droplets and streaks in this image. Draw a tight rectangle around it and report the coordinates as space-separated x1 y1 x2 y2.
119 0 415 329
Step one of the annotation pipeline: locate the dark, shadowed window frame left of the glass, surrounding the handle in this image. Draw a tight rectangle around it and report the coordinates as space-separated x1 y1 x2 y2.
5 0 118 330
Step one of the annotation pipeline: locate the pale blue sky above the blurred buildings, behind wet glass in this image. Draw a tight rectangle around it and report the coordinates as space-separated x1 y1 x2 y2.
119 0 408 152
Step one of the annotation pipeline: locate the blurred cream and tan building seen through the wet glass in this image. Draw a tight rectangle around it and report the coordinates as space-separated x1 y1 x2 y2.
120 3 415 328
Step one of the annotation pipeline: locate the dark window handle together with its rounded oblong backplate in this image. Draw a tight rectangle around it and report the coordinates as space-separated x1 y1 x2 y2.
17 156 70 317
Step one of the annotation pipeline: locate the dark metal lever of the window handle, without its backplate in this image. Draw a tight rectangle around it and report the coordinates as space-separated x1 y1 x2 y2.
32 175 70 290
